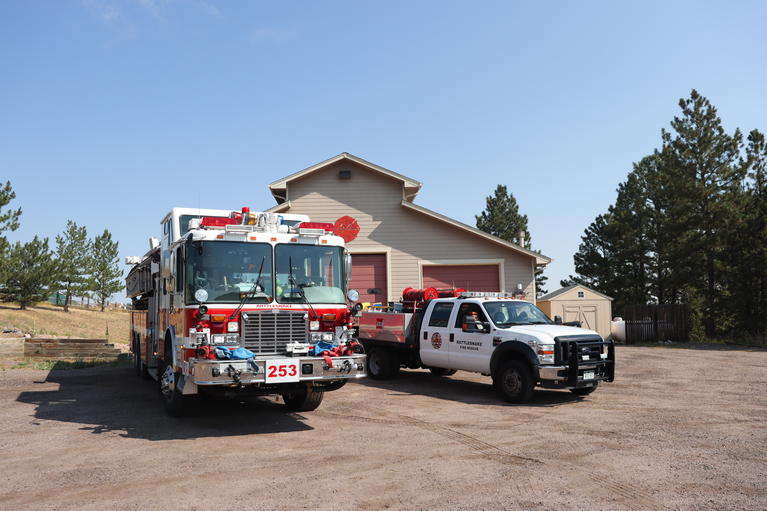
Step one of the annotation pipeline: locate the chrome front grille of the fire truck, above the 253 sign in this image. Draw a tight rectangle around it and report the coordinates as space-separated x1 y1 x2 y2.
241 311 307 355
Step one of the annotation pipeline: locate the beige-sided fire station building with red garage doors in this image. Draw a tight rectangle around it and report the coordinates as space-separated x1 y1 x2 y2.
267 153 551 302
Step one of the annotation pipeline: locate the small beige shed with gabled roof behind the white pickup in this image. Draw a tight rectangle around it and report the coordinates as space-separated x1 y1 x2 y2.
536 284 613 338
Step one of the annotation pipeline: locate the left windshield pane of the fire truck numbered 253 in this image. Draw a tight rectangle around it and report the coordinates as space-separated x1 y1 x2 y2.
185 241 274 303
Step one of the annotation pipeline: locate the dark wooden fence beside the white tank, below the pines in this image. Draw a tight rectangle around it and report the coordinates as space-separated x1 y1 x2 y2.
623 304 690 344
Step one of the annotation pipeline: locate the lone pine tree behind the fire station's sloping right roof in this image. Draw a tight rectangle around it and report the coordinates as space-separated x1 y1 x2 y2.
474 184 548 296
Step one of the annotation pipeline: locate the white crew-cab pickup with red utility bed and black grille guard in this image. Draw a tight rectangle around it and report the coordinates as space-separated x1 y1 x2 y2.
358 293 615 403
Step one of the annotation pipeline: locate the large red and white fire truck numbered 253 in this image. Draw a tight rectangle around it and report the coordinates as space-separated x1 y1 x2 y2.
126 208 366 415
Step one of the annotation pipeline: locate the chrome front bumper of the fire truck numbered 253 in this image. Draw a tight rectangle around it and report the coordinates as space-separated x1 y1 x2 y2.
182 354 367 386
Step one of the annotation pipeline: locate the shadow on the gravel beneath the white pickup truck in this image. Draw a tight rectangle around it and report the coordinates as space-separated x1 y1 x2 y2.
357 370 584 407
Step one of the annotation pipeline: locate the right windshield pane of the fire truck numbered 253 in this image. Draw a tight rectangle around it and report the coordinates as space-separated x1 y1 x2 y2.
274 245 346 303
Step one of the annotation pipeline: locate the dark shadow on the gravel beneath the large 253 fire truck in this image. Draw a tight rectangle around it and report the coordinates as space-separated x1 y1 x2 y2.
16 367 312 440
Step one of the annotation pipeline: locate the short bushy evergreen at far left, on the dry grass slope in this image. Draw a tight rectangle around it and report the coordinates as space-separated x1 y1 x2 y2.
2 236 56 309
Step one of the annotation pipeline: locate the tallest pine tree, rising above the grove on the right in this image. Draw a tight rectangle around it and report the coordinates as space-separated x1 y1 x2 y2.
662 90 744 336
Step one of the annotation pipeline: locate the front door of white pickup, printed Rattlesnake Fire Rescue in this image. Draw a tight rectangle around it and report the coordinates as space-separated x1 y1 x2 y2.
448 303 493 373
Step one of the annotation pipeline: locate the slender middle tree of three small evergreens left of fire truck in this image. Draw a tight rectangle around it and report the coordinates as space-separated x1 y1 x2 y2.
56 220 90 312
